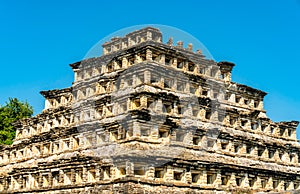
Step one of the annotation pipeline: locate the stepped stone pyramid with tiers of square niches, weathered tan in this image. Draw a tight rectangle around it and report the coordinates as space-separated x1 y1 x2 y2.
0 27 300 194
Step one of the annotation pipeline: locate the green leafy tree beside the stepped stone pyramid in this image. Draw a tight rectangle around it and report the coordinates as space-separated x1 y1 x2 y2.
0 98 33 145
